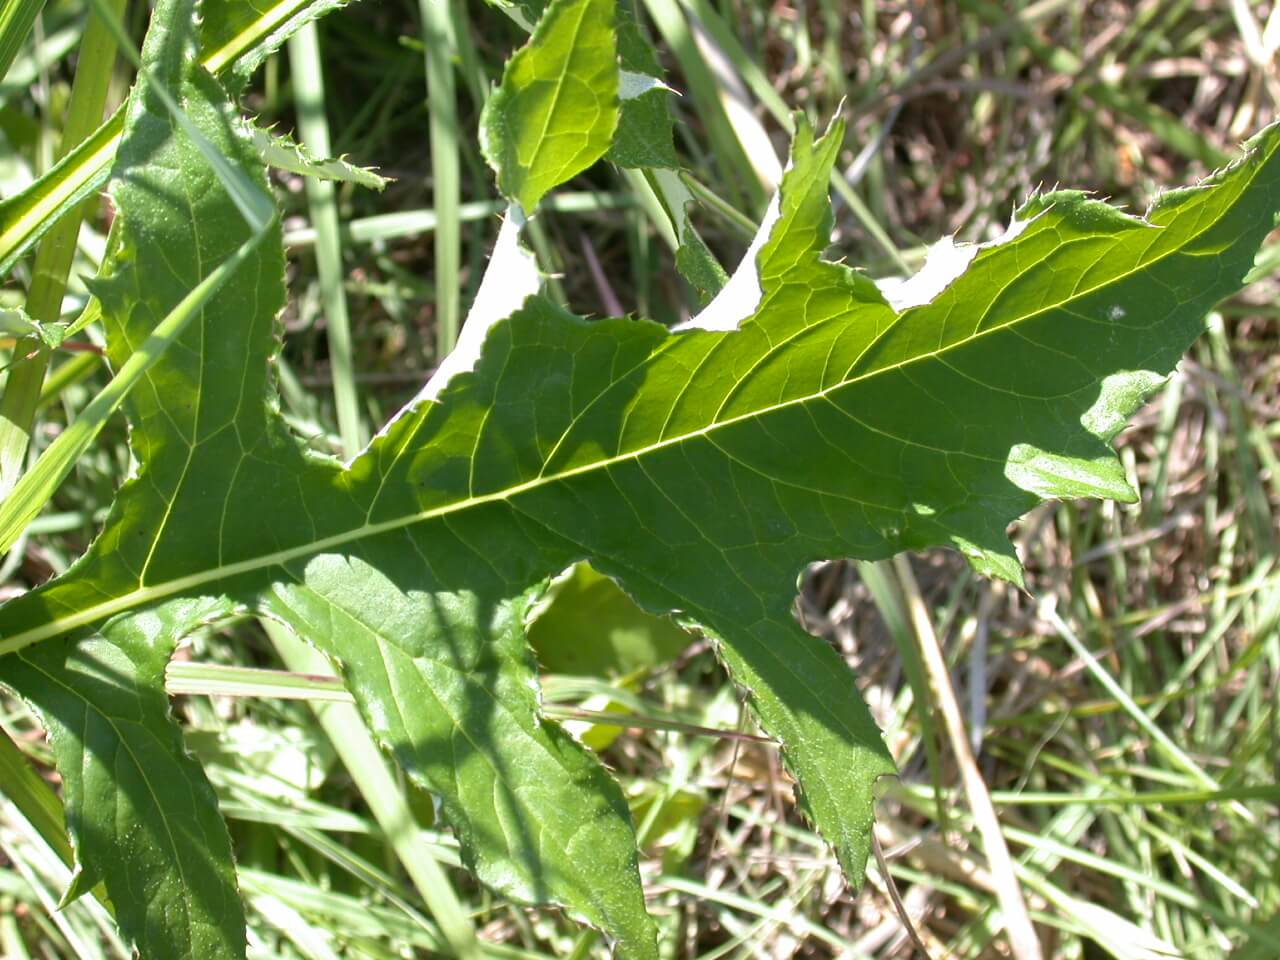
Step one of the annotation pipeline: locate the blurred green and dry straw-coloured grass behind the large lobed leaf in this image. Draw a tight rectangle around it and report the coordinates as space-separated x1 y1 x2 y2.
0 0 1280 959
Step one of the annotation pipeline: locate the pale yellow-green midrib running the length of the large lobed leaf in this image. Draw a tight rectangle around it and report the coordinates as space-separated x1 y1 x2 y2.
0 142 1270 655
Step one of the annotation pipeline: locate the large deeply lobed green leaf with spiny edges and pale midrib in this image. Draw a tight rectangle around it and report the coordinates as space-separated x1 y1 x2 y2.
0 0 1280 957
